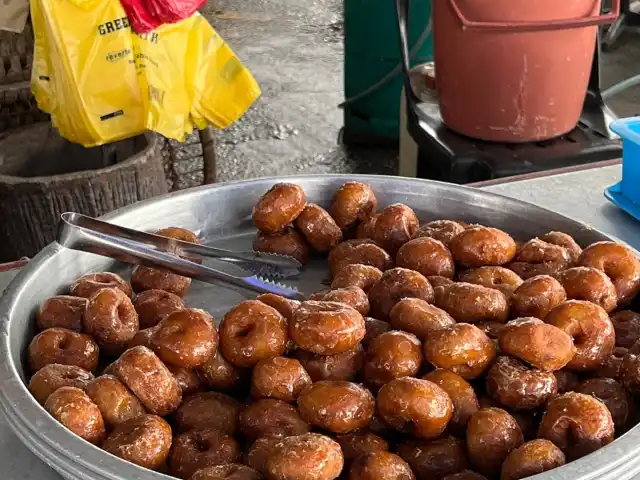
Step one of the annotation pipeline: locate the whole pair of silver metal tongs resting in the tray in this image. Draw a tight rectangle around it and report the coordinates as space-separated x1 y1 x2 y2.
57 212 303 299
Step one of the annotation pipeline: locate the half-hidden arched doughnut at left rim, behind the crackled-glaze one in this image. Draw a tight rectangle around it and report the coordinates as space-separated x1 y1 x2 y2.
29 363 94 405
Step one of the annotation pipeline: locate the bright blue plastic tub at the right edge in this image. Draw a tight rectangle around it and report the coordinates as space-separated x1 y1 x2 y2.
605 117 640 220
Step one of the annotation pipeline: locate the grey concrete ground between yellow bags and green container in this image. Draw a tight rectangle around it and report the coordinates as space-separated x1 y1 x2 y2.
203 0 640 181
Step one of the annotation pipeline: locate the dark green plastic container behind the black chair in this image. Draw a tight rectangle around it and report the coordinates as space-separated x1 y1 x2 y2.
343 0 433 143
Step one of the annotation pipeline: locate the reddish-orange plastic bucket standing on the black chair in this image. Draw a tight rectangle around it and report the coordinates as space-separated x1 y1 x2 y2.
433 0 620 143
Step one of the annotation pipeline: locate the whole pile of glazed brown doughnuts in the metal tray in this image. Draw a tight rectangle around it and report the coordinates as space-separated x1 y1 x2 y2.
27 182 640 480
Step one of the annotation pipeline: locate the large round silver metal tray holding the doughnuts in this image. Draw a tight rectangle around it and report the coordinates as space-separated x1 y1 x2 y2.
0 175 640 480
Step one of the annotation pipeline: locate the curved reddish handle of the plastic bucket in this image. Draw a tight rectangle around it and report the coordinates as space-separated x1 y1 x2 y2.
449 0 620 32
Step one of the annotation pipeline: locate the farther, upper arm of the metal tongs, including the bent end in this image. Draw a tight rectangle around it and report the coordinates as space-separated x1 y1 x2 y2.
58 212 302 278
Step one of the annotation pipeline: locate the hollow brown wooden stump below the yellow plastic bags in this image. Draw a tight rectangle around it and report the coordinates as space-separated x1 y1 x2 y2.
0 123 167 263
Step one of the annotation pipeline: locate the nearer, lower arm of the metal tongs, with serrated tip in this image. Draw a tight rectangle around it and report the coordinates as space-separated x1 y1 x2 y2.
57 213 300 298
